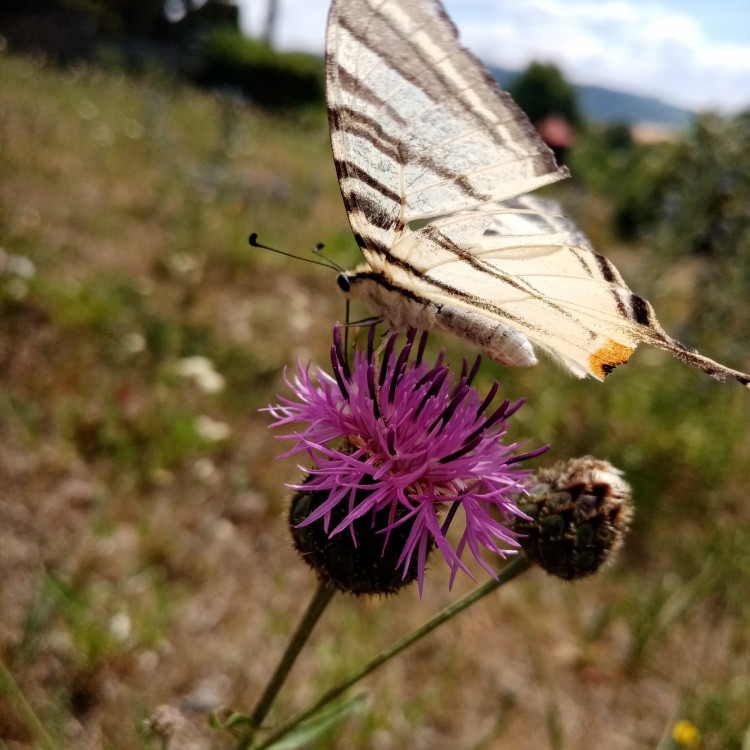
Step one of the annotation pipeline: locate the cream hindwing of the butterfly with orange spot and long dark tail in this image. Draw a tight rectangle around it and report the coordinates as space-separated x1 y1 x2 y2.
390 196 750 385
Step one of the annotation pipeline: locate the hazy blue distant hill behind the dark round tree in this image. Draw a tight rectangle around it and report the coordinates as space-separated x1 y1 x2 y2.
488 65 694 128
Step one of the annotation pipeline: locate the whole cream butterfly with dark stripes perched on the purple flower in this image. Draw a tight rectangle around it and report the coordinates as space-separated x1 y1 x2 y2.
326 0 750 387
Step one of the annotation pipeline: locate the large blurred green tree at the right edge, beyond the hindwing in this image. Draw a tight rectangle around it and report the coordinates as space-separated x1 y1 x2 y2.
608 110 750 346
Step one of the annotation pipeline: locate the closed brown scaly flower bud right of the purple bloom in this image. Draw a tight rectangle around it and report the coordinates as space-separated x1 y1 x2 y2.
513 456 632 580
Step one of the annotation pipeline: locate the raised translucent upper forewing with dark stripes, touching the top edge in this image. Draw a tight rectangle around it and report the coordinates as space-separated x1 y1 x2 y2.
327 0 566 251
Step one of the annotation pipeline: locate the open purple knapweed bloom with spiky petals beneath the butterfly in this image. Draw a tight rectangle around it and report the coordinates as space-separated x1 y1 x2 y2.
268 326 546 593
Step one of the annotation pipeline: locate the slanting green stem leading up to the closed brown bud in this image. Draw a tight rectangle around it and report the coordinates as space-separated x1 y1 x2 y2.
254 553 532 750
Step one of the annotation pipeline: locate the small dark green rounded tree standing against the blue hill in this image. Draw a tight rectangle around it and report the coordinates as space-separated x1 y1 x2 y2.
508 62 583 127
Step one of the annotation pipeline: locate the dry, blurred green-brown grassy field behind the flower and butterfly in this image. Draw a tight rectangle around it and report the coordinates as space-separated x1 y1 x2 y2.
0 50 750 750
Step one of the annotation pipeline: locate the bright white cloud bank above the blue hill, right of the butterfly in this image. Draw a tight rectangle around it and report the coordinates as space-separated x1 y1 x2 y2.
447 0 750 108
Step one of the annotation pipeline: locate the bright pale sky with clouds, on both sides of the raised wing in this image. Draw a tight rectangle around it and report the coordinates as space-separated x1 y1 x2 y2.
237 0 750 112
